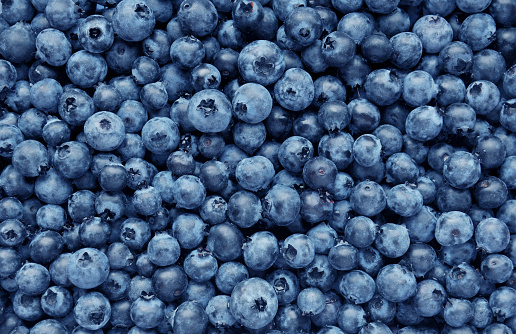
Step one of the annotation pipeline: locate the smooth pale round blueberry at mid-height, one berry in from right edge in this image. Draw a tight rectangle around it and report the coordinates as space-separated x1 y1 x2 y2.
443 151 481 189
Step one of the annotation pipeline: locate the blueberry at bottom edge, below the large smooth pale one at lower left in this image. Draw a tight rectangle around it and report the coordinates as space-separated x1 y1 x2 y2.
73 292 111 330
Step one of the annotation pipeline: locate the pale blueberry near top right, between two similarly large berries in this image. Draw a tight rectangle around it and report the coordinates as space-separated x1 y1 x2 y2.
412 15 453 53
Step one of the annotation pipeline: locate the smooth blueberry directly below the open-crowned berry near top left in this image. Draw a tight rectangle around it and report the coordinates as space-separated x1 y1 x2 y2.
66 50 108 88
